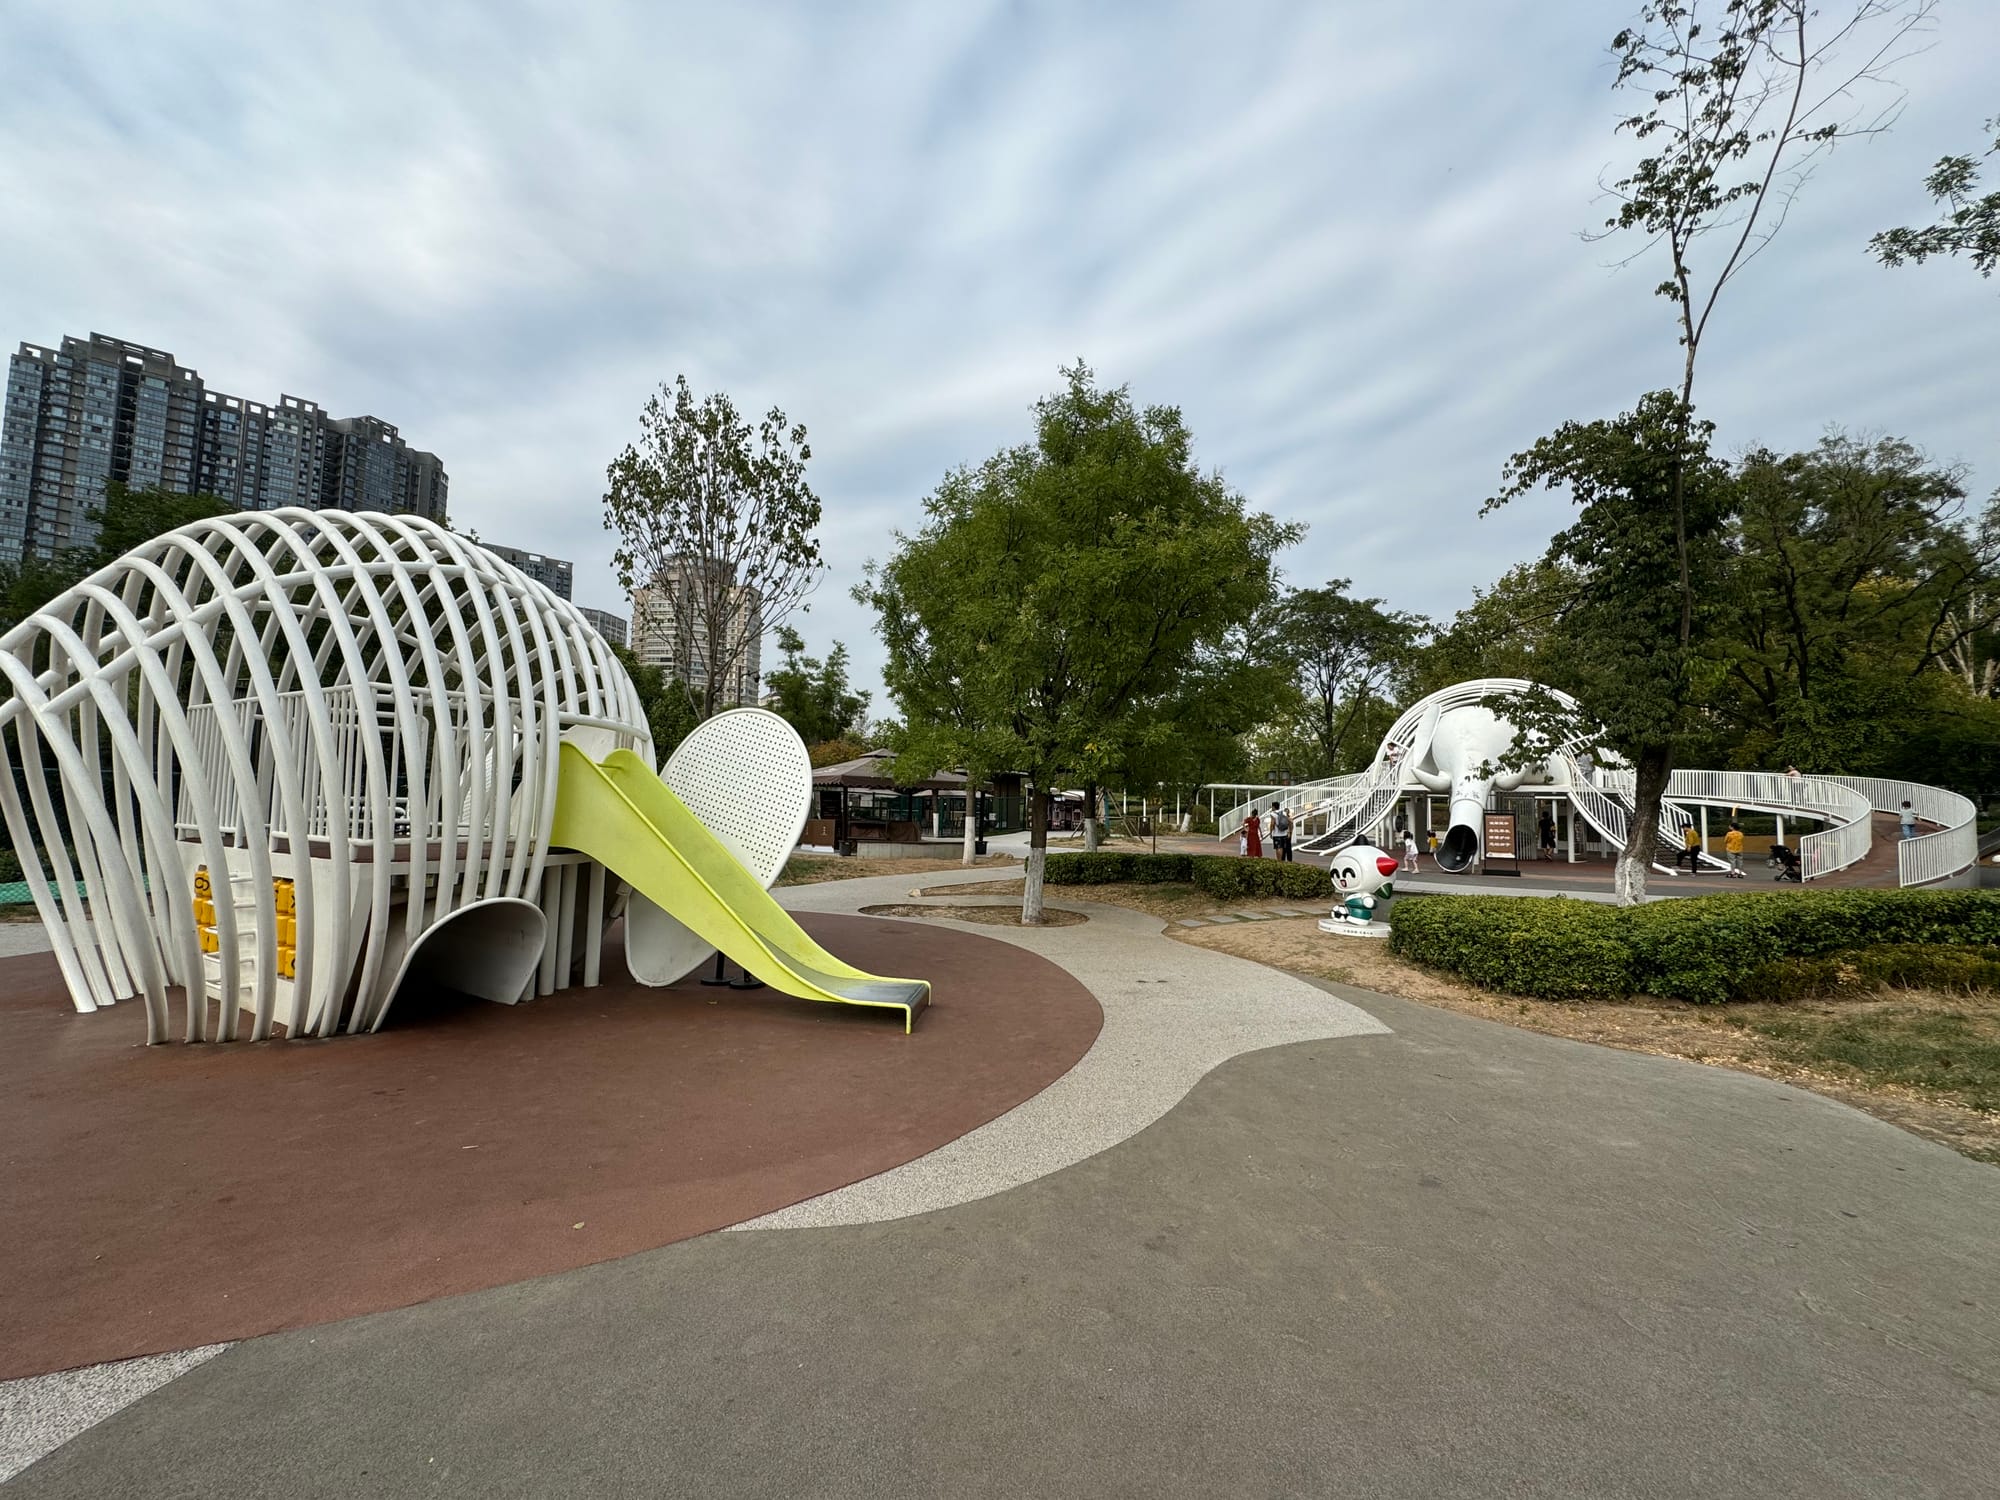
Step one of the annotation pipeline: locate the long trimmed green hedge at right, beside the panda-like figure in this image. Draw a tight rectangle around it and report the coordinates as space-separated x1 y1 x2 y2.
1388 890 2000 1004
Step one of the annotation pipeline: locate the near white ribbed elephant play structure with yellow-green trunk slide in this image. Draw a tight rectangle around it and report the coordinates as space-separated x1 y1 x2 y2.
0 510 930 1042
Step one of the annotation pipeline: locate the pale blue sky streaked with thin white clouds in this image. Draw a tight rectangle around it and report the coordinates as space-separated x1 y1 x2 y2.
0 0 2000 714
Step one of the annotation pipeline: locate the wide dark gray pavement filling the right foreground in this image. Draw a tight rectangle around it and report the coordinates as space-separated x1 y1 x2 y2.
10 992 2000 1500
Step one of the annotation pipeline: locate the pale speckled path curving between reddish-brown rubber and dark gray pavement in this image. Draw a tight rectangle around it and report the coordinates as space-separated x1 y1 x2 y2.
752 870 1388 1230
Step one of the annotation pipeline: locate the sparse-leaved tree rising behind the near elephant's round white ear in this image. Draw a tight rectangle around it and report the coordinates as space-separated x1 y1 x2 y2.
604 376 824 718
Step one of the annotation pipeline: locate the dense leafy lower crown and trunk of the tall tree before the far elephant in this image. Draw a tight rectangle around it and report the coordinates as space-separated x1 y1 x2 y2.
1482 390 1734 902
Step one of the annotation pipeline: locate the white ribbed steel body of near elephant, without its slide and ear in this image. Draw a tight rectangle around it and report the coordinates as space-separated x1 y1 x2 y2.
0 510 652 1042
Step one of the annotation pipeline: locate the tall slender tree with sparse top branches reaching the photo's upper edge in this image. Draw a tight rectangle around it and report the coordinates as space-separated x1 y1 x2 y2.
1496 0 1934 902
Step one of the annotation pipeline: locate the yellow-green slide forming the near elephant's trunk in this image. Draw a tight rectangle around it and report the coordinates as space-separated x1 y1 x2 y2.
550 740 930 1032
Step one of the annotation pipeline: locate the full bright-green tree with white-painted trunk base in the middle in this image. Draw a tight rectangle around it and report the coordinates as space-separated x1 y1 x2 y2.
858 364 1300 924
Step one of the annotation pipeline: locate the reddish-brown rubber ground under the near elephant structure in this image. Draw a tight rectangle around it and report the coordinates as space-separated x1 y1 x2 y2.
0 914 1102 1378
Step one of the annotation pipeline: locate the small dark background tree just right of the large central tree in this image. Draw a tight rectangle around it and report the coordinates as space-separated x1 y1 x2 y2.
1278 578 1430 774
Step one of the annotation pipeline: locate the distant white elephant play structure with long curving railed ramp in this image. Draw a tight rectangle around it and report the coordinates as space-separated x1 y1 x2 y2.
1218 678 1978 886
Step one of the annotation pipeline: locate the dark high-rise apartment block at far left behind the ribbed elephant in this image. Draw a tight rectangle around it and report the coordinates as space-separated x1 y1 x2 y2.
0 334 446 562
